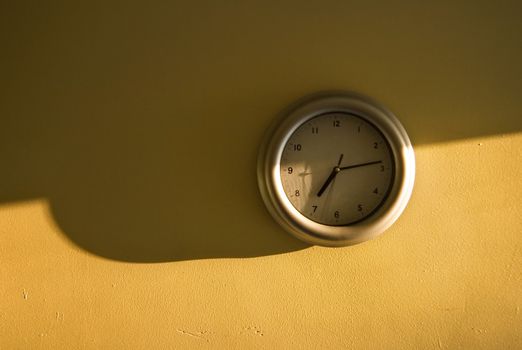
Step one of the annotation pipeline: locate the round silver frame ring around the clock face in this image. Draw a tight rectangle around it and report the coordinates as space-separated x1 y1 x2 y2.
257 92 415 247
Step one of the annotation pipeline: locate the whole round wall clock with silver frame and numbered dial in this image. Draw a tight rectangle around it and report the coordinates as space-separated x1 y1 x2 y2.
257 93 415 246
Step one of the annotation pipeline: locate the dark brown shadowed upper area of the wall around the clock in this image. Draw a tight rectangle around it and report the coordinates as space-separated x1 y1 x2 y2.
0 1 522 262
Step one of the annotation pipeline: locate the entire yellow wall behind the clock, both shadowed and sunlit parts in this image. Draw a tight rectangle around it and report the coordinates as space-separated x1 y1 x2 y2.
0 0 522 349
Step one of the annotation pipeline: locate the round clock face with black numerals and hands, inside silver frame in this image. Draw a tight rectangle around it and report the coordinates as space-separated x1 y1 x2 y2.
279 112 395 226
